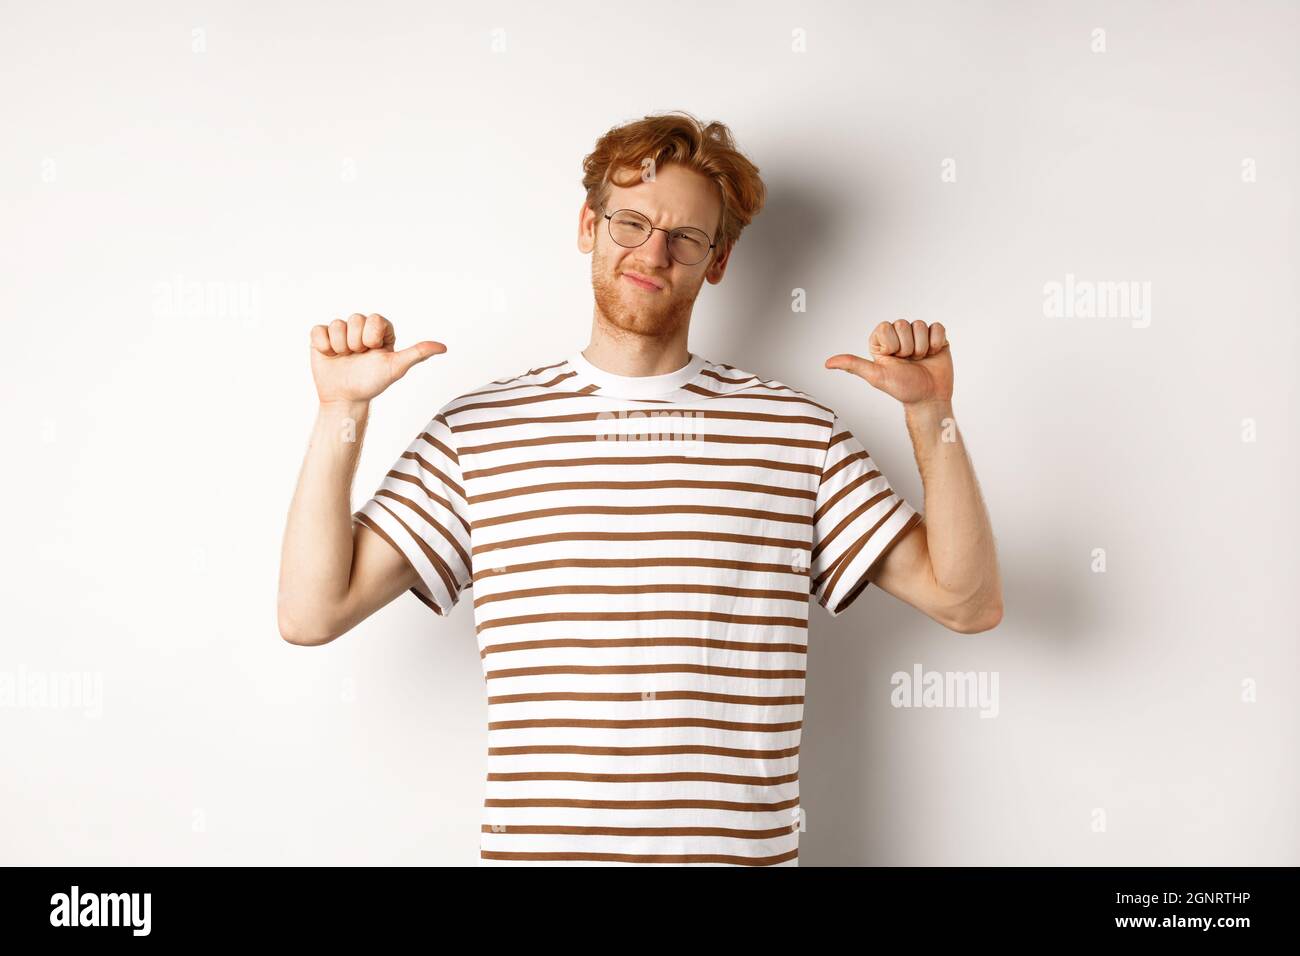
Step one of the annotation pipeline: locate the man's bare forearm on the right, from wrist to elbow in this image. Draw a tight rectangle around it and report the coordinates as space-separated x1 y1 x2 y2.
905 401 1002 610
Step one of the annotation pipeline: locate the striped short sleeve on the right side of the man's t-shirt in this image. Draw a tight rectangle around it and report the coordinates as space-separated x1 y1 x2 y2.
809 415 922 618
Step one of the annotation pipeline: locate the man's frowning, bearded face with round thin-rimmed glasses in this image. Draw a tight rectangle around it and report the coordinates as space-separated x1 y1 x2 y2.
577 164 731 337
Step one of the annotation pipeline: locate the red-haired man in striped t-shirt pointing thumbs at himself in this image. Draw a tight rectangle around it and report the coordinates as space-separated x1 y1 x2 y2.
280 114 1002 866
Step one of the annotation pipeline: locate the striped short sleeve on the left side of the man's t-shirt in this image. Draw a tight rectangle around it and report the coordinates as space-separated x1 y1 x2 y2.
352 411 473 617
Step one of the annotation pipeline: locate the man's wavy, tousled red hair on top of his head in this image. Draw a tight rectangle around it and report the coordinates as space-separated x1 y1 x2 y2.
582 109 767 257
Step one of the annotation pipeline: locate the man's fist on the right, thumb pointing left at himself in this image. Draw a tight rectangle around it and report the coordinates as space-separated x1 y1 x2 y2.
826 319 953 405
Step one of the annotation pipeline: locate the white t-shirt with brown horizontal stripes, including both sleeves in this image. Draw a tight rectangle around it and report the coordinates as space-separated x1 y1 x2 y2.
355 351 920 866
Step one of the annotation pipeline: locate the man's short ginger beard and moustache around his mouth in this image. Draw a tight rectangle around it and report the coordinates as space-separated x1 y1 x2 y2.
592 235 705 337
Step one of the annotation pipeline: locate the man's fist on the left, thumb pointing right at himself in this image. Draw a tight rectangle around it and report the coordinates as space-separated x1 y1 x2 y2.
311 312 447 405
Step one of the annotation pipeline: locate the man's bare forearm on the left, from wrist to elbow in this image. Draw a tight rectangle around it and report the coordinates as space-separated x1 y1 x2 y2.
278 402 369 640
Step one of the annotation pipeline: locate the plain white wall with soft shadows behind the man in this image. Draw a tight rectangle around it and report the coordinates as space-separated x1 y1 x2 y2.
0 1 1300 866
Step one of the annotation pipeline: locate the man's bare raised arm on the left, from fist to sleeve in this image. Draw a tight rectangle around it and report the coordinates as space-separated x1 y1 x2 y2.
277 313 447 645
